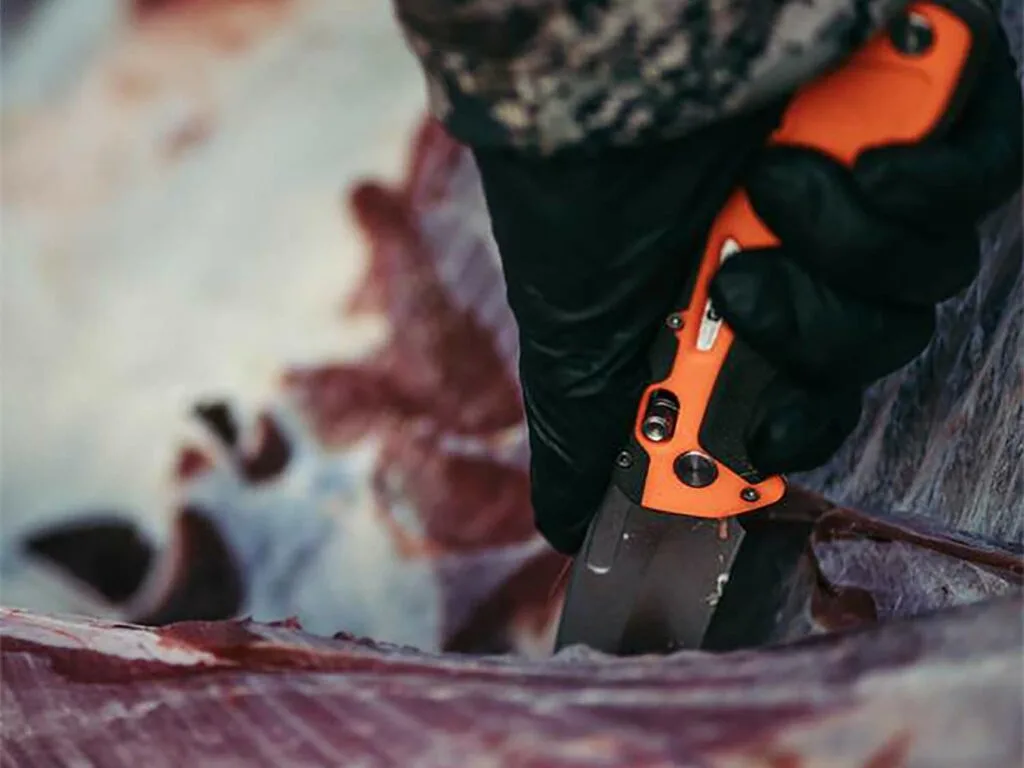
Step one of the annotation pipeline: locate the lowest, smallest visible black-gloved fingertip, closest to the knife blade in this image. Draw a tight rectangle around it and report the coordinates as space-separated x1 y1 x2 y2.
746 378 861 474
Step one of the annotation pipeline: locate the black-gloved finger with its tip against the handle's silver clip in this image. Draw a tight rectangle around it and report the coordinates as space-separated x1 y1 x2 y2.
711 249 935 387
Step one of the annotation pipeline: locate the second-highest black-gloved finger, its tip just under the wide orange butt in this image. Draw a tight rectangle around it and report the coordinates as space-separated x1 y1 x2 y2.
746 146 980 306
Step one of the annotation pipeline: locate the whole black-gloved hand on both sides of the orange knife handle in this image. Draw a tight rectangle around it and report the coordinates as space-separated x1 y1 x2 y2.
475 27 1022 554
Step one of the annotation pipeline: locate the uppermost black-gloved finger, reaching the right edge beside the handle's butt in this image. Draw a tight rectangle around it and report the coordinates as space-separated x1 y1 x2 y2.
853 30 1024 231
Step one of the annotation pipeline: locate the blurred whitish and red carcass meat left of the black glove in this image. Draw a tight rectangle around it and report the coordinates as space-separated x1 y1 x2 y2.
2 0 562 650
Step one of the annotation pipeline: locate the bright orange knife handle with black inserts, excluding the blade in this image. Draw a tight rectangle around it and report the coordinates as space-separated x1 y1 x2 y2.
615 0 991 518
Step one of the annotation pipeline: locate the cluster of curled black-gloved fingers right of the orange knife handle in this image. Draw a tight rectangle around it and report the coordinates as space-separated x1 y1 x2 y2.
711 28 1024 473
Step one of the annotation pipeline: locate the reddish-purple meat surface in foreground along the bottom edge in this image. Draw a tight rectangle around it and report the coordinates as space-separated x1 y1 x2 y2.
0 598 1024 768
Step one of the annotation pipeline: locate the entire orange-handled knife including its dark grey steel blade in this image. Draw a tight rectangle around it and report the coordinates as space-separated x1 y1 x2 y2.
555 0 995 655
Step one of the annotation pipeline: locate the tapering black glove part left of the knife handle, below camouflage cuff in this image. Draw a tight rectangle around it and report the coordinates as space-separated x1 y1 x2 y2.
475 110 780 554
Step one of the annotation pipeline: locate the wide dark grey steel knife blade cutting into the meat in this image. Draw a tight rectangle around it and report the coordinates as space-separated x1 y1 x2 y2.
555 486 811 655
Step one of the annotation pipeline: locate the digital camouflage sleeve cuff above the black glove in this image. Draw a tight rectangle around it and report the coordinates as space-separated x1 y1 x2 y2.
393 0 921 154
